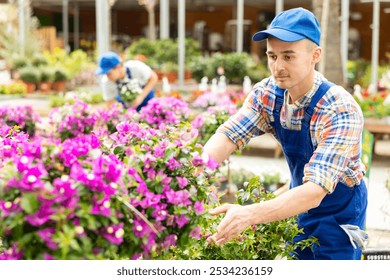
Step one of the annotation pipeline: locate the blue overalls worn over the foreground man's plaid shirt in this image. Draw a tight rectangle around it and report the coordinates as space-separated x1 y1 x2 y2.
271 81 367 260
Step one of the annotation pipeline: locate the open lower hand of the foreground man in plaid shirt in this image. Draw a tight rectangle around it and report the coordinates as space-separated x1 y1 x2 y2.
207 204 251 246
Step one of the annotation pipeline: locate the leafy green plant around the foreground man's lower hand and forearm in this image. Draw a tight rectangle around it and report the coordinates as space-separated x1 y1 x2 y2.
163 177 317 260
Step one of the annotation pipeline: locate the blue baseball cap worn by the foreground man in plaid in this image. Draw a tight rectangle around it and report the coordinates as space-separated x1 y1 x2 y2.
252 8 321 46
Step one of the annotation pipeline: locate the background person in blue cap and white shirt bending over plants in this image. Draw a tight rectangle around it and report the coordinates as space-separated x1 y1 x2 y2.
95 52 158 111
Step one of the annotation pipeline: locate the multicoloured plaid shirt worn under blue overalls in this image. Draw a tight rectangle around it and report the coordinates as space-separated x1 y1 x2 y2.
217 72 365 193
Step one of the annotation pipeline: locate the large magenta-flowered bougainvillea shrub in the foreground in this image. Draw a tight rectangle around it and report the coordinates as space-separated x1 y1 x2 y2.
0 106 216 259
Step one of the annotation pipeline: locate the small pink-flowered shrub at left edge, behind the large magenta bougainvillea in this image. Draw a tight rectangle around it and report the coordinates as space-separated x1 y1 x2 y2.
0 105 40 137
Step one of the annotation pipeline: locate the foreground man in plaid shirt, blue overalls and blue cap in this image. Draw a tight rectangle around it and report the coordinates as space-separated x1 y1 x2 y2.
204 8 367 259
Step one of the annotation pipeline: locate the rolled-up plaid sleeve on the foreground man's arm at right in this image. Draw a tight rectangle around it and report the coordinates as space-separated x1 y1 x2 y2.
303 95 364 193
